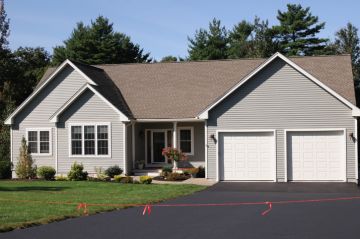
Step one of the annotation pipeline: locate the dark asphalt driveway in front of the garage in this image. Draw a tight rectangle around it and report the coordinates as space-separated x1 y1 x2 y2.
0 183 360 239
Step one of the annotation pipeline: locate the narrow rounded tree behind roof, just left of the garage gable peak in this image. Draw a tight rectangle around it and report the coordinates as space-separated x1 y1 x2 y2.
228 20 254 58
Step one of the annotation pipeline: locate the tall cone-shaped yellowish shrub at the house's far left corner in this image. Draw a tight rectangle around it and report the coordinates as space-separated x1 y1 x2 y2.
15 137 36 179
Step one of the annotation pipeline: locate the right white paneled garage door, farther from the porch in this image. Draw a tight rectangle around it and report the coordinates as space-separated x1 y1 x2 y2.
287 131 346 181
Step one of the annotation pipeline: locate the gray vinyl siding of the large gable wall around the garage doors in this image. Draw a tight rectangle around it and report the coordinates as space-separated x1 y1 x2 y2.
207 60 356 181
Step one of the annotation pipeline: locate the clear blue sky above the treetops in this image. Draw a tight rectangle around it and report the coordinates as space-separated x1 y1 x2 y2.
5 0 360 59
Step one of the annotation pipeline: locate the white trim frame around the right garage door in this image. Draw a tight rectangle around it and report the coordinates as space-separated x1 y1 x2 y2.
284 128 347 182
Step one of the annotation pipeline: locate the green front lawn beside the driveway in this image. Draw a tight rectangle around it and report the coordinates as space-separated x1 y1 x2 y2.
0 181 205 232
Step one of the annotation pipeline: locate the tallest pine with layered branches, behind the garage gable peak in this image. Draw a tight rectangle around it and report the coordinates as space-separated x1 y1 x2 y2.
273 4 328 56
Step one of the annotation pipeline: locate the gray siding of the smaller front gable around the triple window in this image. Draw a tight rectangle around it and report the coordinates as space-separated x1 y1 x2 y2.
58 90 124 174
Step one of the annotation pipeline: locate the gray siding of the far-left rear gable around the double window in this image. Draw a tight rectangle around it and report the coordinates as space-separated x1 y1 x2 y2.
12 67 86 172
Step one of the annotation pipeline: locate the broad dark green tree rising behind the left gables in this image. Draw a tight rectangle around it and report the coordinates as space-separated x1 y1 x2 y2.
53 16 151 65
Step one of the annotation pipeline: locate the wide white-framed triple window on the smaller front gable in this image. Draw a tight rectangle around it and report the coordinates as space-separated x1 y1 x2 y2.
70 123 110 156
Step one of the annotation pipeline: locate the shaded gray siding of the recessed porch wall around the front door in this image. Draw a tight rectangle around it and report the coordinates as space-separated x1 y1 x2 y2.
135 122 205 167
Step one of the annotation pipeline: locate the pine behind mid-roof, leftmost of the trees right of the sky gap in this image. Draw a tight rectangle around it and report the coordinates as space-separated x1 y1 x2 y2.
188 18 228 60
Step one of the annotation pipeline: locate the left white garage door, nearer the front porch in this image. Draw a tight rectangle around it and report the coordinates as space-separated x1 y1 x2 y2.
219 132 276 181
